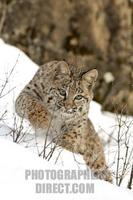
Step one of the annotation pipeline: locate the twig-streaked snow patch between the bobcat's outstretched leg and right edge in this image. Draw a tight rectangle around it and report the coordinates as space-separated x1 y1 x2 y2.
89 102 133 186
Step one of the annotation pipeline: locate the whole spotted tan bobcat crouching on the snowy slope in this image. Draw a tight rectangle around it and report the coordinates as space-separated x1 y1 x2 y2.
15 61 112 182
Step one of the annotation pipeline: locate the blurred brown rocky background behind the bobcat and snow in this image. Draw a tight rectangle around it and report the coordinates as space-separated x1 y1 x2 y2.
0 0 133 115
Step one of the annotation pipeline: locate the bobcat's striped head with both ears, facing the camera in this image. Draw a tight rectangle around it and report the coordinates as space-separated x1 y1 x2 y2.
47 61 98 118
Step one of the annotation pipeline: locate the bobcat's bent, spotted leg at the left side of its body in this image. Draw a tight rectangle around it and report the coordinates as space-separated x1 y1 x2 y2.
15 92 50 129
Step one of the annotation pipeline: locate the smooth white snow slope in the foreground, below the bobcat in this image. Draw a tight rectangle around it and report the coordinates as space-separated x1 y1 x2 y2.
0 139 133 200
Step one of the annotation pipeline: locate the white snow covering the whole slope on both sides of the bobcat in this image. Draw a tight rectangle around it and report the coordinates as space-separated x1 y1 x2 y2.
0 40 133 199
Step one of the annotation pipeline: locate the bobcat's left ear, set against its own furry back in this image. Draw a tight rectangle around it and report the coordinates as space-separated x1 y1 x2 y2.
56 61 70 75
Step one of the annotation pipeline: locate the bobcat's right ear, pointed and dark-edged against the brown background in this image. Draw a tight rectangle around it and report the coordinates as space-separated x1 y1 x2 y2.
82 69 98 89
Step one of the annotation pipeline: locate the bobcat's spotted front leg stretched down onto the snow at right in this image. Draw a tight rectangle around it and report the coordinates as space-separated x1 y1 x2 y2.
83 121 112 182
